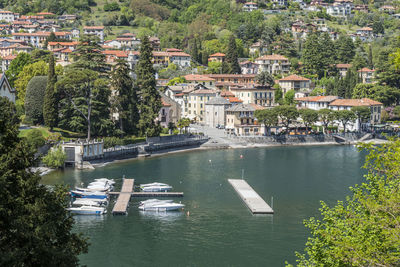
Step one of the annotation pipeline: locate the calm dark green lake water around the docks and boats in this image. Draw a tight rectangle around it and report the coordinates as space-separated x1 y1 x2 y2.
42 146 364 267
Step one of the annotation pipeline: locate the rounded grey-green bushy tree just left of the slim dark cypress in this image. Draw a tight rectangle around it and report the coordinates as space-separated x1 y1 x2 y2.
25 76 47 124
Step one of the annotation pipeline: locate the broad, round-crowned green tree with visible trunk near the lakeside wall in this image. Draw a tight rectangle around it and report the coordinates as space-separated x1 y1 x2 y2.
56 69 113 140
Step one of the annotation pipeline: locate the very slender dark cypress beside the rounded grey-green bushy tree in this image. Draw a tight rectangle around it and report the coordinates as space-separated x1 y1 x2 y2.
43 54 58 130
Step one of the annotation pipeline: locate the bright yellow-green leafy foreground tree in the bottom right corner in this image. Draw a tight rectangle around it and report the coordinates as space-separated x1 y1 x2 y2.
288 139 400 267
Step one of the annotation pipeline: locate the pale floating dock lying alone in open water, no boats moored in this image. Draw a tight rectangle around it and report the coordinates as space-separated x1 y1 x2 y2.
228 179 274 214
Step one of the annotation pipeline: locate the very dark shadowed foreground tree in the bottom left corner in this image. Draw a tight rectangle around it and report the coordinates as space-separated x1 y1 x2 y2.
0 97 88 266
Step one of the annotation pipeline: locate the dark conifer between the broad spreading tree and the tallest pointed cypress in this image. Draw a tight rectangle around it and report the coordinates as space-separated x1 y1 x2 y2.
111 60 139 137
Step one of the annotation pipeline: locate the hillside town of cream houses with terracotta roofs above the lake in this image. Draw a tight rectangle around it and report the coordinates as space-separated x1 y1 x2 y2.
0 0 397 140
